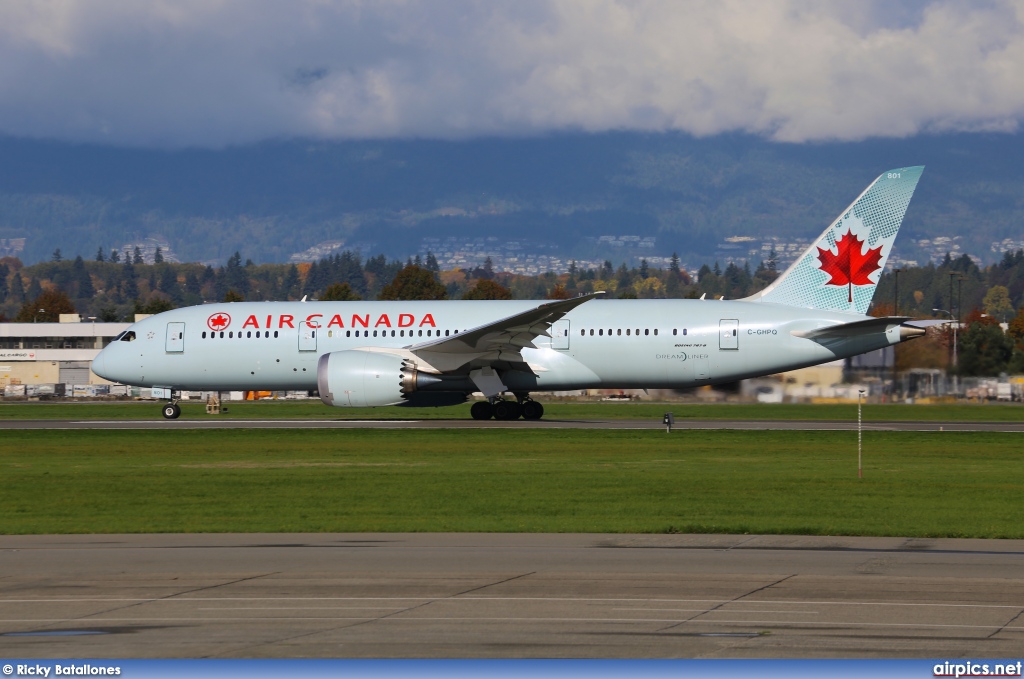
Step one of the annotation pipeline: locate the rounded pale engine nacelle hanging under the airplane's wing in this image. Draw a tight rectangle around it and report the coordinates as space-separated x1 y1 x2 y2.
316 350 419 408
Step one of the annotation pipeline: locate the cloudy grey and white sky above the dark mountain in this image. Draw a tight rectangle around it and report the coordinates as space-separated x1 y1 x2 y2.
0 0 1024 147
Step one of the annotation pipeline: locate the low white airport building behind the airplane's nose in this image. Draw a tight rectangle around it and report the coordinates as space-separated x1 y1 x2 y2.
0 313 131 395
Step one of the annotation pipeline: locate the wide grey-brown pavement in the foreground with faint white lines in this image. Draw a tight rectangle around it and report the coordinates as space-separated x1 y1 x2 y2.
0 532 1024 659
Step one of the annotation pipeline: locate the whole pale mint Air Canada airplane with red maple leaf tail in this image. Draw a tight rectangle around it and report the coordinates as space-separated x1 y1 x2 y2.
92 166 925 420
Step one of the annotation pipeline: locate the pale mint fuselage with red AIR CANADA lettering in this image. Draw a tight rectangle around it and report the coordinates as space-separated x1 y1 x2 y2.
93 299 900 392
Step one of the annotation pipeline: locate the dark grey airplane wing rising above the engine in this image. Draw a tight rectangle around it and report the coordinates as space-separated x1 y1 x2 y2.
406 292 604 373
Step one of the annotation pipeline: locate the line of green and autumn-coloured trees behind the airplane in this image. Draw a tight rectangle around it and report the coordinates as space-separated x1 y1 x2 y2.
0 250 1024 375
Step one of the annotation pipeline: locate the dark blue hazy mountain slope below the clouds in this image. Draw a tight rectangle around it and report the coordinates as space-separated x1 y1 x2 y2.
0 134 1024 265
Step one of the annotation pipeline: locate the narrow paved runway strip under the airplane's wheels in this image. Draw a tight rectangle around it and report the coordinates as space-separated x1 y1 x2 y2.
6 418 1024 432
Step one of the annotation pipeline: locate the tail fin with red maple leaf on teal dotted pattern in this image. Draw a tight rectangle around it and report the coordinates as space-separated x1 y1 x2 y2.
746 166 925 314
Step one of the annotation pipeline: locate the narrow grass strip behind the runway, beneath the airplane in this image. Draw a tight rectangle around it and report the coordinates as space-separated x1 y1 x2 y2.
0 400 1024 422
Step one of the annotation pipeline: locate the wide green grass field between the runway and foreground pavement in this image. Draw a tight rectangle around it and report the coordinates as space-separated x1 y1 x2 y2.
0 430 1024 538
